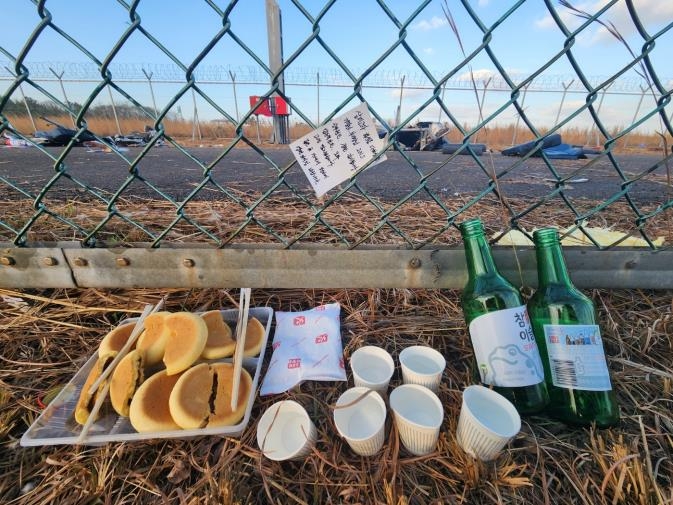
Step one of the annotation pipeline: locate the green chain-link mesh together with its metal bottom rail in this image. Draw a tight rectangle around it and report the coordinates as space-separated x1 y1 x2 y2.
0 0 673 287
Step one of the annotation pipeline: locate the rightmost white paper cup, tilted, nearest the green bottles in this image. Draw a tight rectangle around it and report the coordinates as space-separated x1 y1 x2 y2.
456 385 521 461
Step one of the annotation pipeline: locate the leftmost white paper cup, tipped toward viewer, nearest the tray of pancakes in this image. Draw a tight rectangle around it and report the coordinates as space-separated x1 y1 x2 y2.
257 400 318 461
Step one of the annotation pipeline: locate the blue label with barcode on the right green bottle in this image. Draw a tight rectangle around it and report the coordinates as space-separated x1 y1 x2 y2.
544 324 612 391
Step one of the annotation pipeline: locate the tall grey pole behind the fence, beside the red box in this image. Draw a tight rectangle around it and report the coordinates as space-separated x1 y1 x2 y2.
266 0 290 144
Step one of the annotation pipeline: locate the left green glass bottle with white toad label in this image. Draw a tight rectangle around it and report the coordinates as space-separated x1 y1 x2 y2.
460 219 549 414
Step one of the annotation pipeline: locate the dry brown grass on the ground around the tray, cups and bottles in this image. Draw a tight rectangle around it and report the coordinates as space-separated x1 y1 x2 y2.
0 194 673 505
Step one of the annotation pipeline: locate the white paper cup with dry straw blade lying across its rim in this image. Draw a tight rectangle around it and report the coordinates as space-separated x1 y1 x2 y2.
334 387 386 456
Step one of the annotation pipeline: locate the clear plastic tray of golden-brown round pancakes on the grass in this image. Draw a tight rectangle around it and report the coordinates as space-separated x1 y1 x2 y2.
21 307 273 446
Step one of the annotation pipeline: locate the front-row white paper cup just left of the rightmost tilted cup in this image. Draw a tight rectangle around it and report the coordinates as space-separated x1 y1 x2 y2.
390 384 444 456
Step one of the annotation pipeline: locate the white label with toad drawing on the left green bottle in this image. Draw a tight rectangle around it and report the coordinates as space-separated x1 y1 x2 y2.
469 305 544 387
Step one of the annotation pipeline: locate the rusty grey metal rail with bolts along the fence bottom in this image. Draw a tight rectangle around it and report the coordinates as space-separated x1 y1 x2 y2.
0 244 673 289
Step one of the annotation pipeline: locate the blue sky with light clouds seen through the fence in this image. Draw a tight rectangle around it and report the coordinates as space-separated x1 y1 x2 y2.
0 0 673 134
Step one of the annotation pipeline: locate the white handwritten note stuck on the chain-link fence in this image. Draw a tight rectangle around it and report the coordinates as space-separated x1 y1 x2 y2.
290 102 386 196
